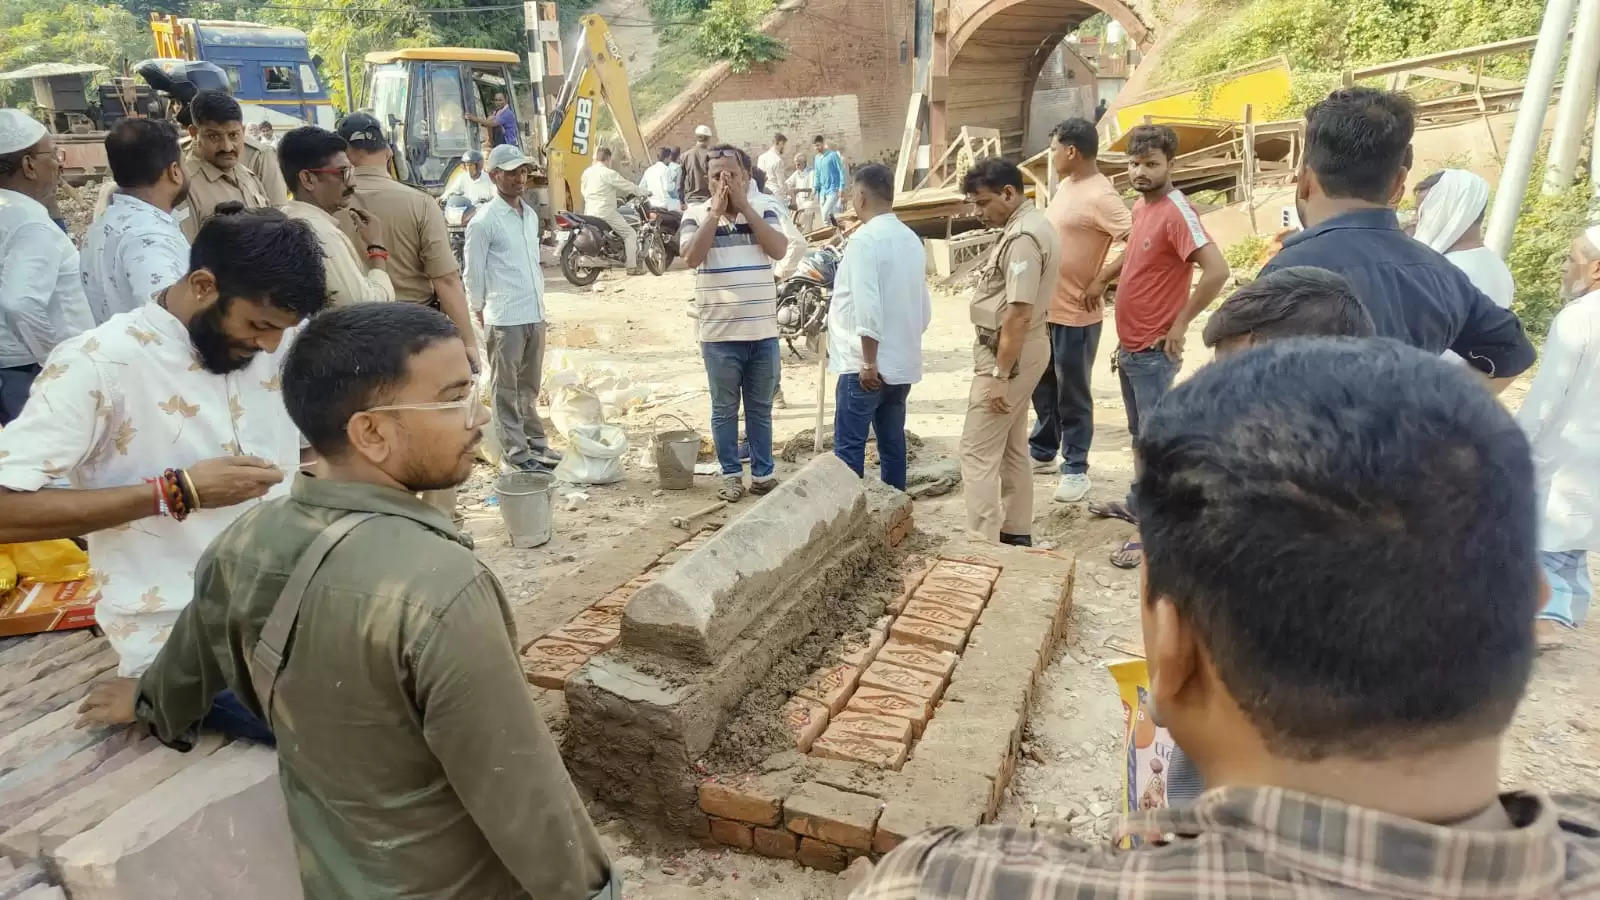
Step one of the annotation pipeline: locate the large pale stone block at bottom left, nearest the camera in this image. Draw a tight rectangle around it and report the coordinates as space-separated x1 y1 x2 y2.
53 745 304 900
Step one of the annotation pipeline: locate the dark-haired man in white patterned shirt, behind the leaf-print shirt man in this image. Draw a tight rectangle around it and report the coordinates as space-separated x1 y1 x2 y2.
80 119 189 325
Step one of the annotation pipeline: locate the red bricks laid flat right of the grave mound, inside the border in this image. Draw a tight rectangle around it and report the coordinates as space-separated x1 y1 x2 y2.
782 560 998 770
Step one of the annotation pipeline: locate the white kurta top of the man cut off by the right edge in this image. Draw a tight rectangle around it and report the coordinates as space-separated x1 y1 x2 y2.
1517 290 1600 551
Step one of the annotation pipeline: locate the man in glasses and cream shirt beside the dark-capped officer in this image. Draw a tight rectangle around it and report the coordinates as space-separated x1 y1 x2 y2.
278 125 395 306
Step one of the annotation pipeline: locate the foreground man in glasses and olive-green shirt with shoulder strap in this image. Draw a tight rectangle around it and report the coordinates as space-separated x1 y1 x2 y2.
82 302 619 900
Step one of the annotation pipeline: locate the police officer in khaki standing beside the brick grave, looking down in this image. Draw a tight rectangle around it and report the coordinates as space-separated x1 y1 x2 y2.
960 159 1061 546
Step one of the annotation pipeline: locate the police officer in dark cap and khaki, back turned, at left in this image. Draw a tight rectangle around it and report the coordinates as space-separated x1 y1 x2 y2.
336 112 478 370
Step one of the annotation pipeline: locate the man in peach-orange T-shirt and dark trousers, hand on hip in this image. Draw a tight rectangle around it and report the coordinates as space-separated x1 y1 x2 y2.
1027 119 1133 503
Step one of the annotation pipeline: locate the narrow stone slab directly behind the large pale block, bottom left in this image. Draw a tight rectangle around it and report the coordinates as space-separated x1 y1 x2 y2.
0 735 222 858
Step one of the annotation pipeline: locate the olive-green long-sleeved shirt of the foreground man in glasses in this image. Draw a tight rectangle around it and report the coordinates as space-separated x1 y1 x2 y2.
138 476 608 900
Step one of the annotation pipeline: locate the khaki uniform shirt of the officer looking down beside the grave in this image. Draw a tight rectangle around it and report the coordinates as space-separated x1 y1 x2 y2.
971 200 1061 375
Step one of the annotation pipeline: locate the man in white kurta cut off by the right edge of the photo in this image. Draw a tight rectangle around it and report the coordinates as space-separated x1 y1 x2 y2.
1517 226 1600 649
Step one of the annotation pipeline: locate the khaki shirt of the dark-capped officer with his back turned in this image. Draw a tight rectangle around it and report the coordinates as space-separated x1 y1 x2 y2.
347 165 459 303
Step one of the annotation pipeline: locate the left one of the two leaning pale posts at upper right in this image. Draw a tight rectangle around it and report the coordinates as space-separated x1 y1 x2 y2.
1483 0 1574 259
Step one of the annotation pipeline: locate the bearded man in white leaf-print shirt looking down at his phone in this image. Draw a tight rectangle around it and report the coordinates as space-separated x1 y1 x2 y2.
0 210 326 707
